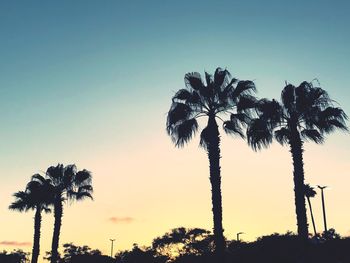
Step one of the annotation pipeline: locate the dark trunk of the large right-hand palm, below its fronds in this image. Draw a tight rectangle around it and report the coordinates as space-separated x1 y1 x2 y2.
289 126 308 240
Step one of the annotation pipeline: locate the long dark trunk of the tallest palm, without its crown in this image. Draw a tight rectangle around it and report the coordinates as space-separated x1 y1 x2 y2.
208 116 226 262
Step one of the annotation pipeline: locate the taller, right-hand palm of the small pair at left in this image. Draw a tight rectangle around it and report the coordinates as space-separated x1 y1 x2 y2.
46 164 93 263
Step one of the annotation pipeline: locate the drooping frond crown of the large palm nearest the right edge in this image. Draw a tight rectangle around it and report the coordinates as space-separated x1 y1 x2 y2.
247 81 348 150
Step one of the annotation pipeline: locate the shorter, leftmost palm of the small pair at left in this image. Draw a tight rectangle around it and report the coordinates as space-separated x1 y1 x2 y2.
9 175 53 263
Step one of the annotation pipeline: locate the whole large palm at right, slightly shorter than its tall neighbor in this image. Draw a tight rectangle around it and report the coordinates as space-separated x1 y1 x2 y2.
247 81 347 240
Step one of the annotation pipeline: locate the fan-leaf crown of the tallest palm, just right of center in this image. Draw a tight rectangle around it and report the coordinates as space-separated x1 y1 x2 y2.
167 68 256 148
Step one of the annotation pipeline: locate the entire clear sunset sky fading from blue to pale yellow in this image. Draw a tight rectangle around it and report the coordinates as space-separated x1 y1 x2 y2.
0 0 350 262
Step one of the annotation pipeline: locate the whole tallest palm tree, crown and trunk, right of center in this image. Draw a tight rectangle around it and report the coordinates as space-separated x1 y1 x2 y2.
166 68 255 255
